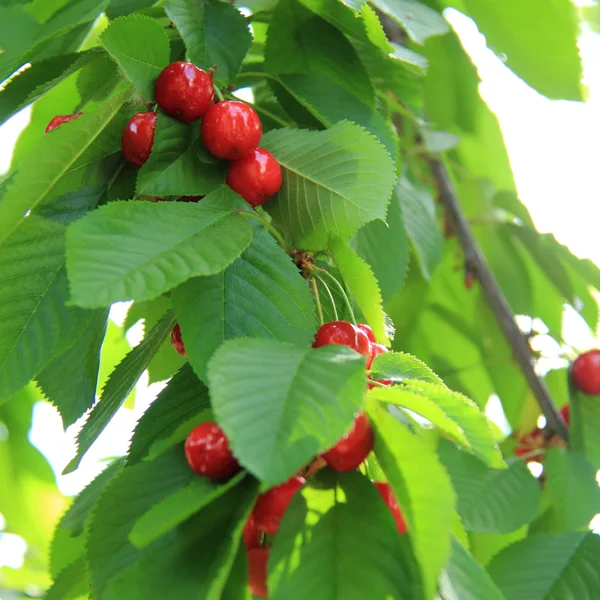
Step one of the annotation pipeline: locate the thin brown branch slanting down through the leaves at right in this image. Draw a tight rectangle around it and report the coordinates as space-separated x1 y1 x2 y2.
430 160 569 441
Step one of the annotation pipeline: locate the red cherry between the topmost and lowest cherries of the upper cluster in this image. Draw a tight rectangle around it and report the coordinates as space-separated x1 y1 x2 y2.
202 100 262 160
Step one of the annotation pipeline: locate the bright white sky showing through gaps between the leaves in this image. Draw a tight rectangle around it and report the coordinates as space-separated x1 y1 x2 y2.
0 9 600 566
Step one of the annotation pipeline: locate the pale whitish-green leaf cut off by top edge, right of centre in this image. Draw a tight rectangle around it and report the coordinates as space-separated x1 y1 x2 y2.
373 0 450 44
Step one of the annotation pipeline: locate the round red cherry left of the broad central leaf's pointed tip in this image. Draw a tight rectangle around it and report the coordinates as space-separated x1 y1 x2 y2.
185 421 241 479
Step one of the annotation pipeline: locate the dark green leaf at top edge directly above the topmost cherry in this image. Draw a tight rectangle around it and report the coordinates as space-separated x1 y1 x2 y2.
164 0 252 84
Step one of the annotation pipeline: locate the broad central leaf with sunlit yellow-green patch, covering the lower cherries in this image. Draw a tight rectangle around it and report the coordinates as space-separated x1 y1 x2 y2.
208 339 365 486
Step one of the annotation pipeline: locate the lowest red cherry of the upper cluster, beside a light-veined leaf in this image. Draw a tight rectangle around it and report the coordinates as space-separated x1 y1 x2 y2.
227 148 282 207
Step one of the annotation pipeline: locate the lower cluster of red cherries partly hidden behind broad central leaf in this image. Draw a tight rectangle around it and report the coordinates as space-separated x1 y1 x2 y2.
182 321 406 598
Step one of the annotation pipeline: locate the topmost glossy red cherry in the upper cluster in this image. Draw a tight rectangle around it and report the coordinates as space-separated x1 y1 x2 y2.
154 60 215 123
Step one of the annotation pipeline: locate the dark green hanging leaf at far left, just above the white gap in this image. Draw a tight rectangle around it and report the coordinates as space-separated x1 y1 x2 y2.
36 310 108 429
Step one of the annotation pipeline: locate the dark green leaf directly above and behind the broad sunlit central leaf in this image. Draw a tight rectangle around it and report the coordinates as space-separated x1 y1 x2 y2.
172 228 316 378
